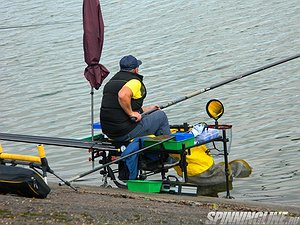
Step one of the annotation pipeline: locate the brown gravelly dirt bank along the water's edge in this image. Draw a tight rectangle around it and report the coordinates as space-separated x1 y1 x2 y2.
0 184 300 225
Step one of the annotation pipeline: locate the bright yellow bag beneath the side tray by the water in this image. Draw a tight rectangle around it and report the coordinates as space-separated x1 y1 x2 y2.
172 145 214 177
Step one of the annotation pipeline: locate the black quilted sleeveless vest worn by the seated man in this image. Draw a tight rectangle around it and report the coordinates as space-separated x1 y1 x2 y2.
100 71 147 138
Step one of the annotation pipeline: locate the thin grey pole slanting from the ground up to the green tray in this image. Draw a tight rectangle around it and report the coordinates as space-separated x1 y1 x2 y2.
64 136 174 185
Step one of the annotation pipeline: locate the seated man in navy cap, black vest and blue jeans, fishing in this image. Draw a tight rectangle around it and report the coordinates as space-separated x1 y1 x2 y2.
100 55 179 174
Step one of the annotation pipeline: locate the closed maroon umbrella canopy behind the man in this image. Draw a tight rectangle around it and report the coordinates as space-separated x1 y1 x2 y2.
83 0 109 90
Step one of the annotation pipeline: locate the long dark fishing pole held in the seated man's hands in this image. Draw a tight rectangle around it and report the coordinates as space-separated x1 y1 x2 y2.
141 54 300 116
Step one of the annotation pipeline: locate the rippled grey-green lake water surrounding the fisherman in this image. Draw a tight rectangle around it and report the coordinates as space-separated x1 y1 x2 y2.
0 0 300 205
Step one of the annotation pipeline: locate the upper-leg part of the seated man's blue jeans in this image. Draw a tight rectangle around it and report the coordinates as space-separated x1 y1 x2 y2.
114 110 171 141
